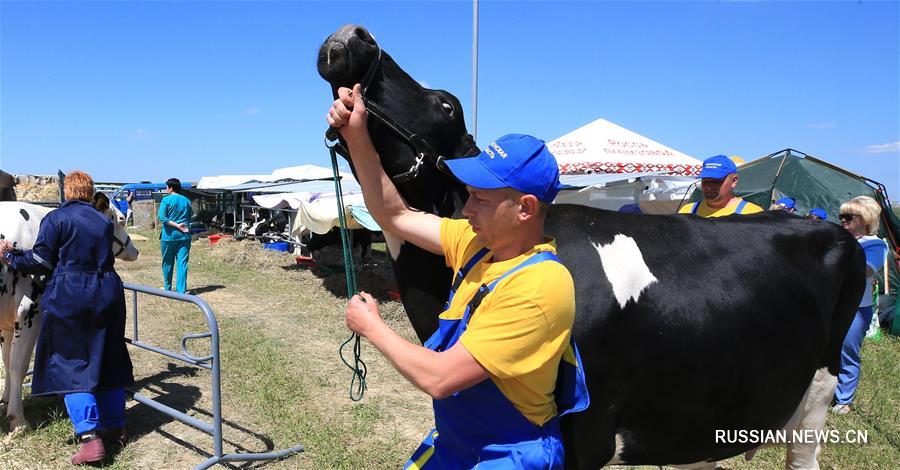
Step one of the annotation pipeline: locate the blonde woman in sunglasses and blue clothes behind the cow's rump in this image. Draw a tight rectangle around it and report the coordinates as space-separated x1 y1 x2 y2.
832 196 887 414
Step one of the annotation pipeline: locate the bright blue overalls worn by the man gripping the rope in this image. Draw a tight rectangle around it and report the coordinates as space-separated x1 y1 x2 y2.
404 248 590 470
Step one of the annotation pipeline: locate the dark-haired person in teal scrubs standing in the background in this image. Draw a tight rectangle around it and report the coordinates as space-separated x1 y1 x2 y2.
159 178 191 294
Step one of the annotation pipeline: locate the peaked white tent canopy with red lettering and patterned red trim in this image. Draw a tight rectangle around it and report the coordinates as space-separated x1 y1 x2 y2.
547 119 702 176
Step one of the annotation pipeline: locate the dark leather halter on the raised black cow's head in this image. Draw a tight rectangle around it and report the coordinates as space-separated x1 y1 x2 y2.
325 46 451 183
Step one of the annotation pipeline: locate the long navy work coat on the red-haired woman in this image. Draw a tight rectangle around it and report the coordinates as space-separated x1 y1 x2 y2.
8 200 134 396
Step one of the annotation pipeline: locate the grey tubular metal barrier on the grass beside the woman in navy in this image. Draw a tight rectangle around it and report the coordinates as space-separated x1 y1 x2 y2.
125 282 303 470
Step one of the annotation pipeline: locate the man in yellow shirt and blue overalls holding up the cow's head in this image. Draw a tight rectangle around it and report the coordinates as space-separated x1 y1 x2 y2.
327 85 588 469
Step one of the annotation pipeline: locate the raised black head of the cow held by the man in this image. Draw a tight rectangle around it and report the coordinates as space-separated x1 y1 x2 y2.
318 25 479 216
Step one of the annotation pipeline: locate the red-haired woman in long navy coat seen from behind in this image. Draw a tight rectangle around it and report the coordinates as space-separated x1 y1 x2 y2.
0 171 134 465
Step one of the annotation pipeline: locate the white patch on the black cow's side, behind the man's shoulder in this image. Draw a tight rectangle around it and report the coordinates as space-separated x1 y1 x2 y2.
594 233 657 308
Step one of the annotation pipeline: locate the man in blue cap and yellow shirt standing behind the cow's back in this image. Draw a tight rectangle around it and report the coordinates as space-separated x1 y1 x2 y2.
678 155 763 217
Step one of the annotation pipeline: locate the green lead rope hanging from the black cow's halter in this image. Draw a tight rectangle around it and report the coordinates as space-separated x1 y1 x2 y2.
325 142 366 401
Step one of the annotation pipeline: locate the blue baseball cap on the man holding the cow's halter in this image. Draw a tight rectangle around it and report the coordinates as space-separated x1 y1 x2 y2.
446 134 562 203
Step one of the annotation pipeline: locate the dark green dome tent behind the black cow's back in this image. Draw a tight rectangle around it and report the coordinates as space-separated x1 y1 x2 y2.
692 149 900 333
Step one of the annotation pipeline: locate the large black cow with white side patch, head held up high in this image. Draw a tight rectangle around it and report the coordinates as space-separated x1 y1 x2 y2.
318 25 865 469
